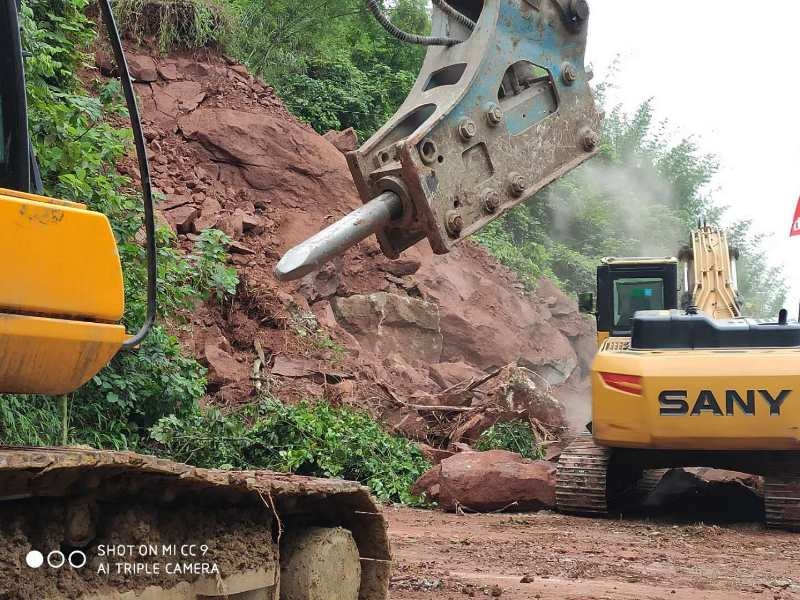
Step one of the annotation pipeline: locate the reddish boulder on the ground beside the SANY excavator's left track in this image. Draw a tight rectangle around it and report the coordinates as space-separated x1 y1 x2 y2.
413 450 556 512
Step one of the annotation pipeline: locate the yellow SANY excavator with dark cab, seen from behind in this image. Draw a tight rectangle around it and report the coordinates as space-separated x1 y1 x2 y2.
556 223 800 530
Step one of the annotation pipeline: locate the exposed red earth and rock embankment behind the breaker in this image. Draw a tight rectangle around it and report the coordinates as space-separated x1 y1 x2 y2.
112 52 594 443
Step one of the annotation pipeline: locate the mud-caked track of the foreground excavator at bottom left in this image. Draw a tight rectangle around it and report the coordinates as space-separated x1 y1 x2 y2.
0 448 391 600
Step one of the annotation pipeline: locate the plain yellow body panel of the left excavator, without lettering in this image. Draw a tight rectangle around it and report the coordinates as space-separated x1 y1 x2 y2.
0 189 126 394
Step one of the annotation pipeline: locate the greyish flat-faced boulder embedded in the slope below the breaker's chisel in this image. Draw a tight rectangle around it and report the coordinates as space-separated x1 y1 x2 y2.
331 292 442 364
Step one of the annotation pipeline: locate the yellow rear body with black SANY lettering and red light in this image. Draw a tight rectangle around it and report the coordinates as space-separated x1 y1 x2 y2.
592 343 800 450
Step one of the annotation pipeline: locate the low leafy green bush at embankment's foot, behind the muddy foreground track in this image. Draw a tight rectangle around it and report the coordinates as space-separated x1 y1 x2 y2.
152 398 430 504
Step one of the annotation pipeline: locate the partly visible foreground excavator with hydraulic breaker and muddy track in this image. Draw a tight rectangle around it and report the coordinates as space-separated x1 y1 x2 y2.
0 0 600 600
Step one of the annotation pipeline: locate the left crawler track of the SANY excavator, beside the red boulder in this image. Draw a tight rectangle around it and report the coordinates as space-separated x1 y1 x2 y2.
556 432 611 516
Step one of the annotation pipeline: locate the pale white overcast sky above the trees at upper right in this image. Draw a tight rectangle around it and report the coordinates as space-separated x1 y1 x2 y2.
586 0 800 315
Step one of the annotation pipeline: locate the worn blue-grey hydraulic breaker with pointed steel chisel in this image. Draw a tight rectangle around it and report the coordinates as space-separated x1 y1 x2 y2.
276 0 602 280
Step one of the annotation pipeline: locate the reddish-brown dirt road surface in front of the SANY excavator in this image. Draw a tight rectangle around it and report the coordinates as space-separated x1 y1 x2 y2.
386 508 800 600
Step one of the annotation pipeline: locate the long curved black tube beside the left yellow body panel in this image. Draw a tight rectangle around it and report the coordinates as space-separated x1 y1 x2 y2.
100 0 158 348
